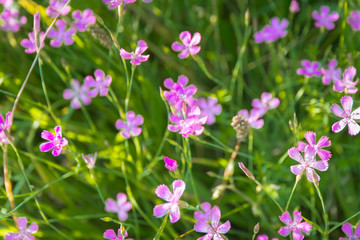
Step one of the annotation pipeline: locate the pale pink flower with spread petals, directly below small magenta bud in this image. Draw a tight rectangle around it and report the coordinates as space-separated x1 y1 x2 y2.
153 180 186 223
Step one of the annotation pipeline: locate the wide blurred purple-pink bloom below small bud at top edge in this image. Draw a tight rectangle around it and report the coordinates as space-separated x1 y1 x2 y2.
254 17 289 43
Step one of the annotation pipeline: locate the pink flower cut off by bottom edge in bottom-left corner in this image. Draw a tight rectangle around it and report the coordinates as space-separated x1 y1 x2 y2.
4 217 39 240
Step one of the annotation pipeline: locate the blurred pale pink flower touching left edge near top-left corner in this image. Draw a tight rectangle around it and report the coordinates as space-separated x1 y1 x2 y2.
0 9 27 32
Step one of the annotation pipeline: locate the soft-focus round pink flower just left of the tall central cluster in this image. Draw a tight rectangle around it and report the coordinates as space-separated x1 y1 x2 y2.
115 111 144 139
